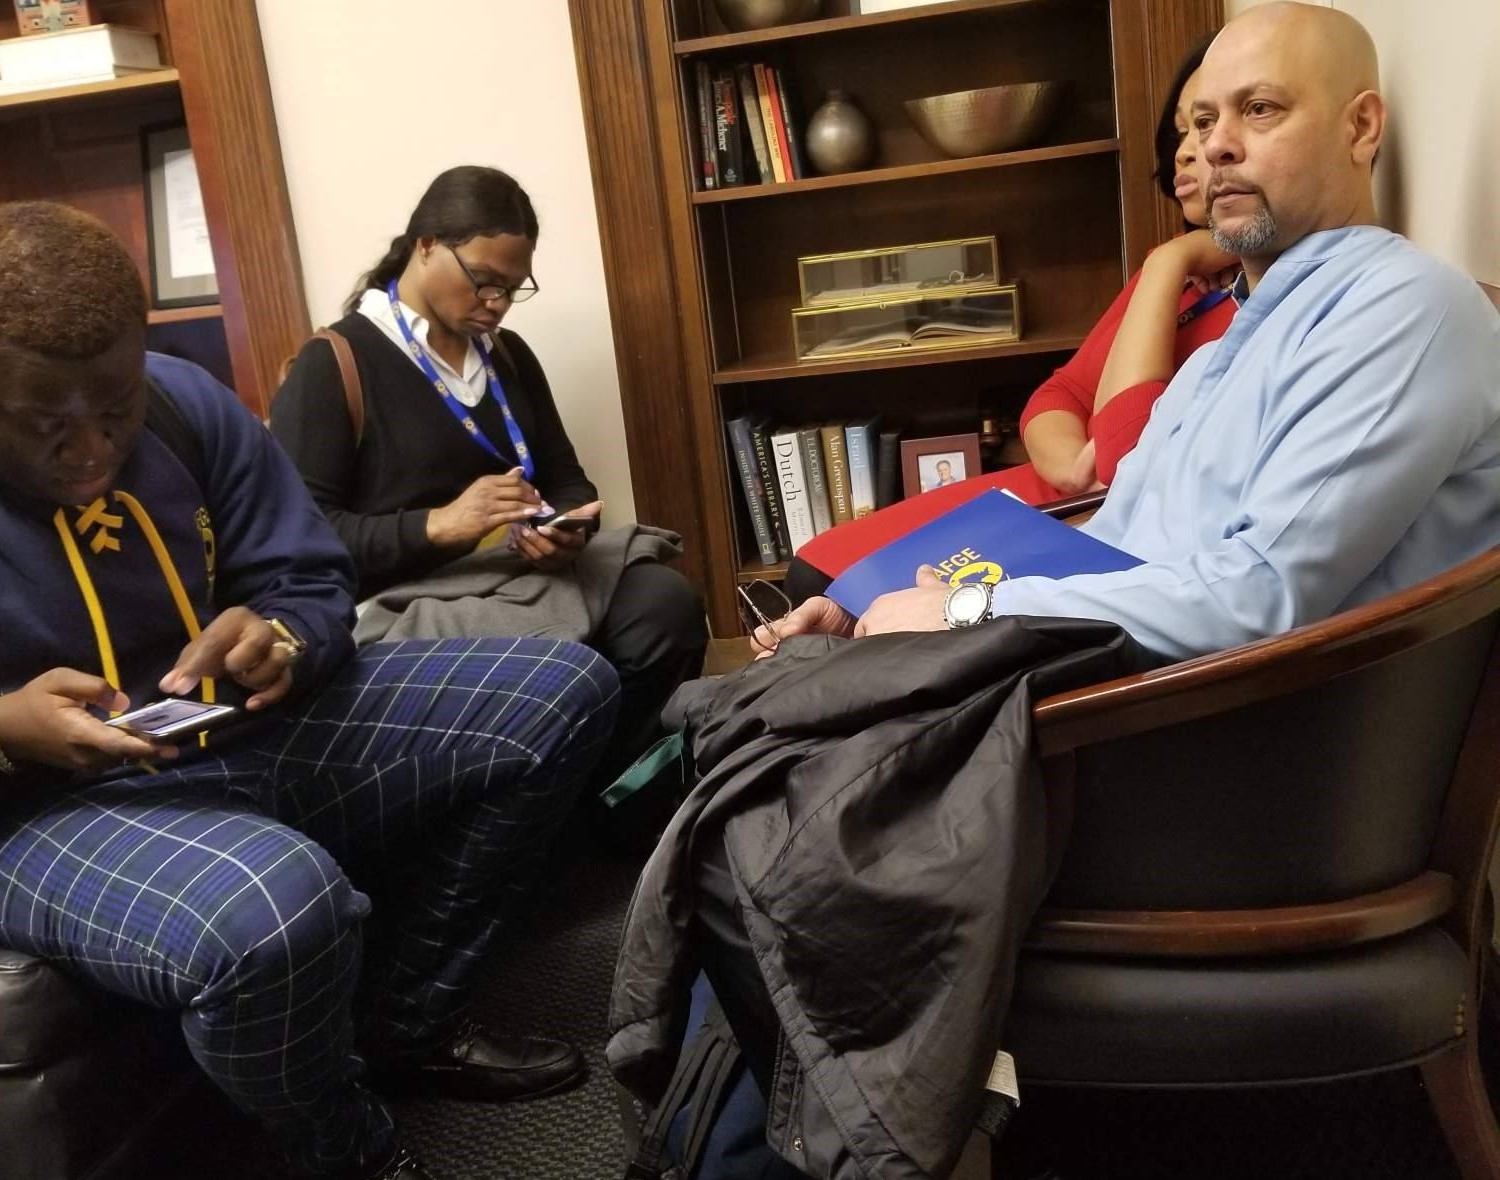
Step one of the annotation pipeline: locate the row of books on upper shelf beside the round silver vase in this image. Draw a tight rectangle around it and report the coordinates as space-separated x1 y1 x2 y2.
693 60 809 189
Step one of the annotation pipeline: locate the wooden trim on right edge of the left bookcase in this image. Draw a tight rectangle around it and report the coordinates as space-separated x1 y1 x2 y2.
167 0 309 417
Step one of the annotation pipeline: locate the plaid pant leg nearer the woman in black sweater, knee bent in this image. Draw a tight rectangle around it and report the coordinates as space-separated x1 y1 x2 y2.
237 639 618 1056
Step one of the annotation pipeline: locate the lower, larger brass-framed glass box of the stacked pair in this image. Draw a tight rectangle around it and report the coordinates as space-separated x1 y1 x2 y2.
792 283 1022 361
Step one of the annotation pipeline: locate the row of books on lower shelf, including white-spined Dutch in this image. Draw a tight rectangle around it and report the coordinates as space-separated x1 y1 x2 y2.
728 415 902 565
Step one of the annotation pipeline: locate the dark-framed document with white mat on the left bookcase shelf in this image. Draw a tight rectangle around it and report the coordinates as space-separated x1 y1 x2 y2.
141 123 219 307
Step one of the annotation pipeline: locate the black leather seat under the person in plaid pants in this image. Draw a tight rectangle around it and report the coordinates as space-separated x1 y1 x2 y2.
0 949 198 1180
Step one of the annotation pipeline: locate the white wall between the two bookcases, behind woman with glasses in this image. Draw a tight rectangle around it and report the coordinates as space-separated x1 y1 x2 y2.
257 0 635 523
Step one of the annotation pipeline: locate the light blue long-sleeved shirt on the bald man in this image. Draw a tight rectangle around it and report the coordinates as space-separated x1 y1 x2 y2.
992 226 1500 658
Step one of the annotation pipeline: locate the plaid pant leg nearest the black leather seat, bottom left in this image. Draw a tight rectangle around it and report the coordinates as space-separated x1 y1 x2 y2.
0 779 393 1173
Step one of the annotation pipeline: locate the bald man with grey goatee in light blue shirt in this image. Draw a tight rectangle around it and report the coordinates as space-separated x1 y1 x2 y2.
759 3 1500 658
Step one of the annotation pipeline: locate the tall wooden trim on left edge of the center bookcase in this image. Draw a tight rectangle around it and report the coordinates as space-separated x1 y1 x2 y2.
569 0 708 588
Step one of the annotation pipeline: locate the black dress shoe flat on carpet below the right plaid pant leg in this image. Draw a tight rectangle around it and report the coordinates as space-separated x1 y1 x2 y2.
375 1021 588 1102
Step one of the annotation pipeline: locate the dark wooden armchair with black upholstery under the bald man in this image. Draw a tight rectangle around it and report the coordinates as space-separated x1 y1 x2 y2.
960 550 1500 1180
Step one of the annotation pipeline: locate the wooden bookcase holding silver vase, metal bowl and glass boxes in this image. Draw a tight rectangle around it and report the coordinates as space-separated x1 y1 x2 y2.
573 0 1221 634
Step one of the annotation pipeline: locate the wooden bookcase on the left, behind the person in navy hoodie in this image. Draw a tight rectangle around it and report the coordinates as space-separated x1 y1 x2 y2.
0 0 308 414
